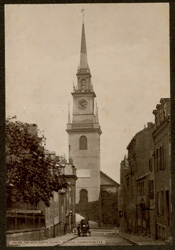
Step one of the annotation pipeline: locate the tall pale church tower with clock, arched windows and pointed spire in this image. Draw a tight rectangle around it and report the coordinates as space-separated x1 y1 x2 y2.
66 22 102 204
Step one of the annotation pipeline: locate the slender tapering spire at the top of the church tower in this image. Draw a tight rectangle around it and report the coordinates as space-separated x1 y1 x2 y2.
80 22 88 69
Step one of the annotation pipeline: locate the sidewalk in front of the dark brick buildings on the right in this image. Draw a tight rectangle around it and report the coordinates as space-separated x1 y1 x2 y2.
119 232 167 246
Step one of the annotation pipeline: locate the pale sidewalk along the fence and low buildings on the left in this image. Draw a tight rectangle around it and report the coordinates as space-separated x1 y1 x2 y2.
8 233 78 247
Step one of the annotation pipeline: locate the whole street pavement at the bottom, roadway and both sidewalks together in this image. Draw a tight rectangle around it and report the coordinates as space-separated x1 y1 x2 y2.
7 228 171 247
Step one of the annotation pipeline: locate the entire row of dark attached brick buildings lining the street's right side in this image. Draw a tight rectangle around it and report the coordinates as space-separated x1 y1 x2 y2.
119 98 172 240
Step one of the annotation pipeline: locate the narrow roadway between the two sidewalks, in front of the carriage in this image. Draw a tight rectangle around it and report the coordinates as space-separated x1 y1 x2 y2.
59 229 133 246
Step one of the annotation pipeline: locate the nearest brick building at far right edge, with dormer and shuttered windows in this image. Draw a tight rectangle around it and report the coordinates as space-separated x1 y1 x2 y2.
153 98 172 239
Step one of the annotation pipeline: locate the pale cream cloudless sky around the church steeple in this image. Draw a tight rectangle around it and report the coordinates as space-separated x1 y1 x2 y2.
5 3 170 182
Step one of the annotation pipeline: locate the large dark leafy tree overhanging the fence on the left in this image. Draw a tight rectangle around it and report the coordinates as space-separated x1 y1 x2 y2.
6 117 66 206
